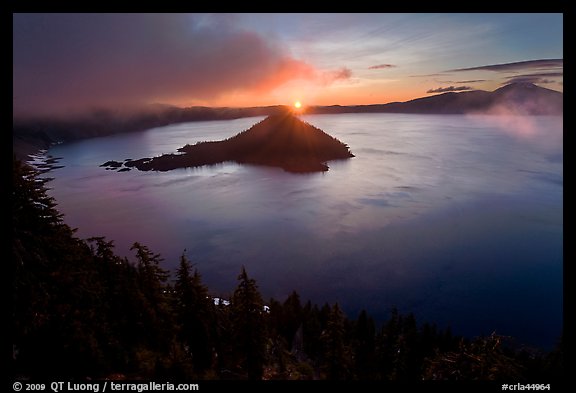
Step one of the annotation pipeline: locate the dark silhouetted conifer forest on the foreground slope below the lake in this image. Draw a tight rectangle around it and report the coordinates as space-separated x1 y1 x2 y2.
11 160 564 382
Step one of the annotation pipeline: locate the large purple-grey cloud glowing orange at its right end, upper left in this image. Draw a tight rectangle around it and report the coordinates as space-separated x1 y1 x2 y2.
13 14 324 113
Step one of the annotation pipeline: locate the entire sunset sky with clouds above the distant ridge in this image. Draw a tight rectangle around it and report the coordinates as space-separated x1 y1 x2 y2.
13 13 563 115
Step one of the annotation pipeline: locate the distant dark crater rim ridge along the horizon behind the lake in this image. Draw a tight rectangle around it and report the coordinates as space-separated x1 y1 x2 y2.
12 83 564 159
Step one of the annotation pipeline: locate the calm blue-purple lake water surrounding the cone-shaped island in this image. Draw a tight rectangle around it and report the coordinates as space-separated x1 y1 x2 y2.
39 114 563 348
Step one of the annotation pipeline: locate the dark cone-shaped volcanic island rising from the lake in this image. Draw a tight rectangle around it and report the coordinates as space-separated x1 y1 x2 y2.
100 111 354 173
